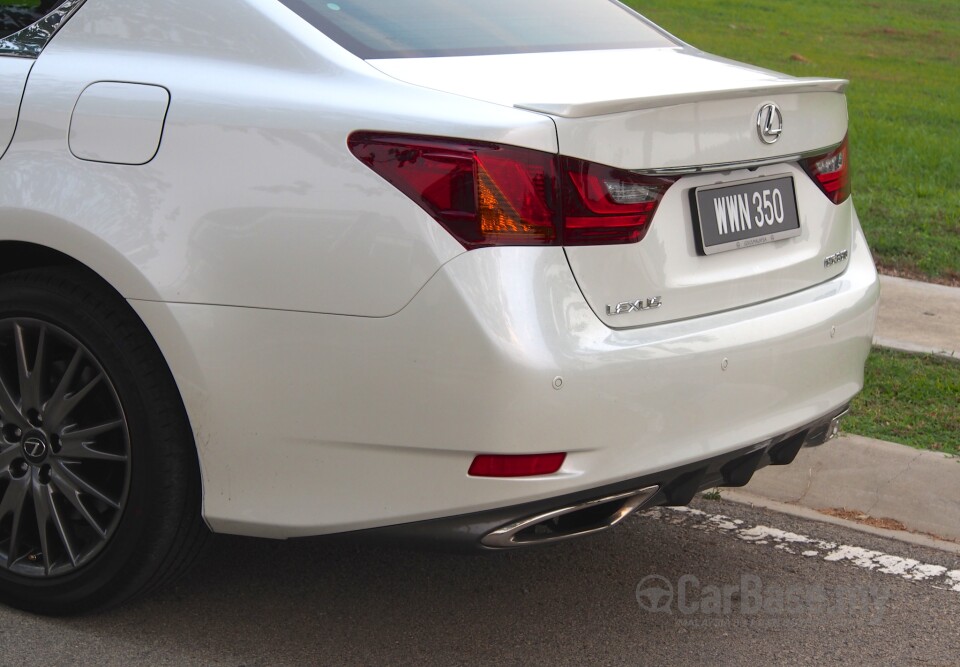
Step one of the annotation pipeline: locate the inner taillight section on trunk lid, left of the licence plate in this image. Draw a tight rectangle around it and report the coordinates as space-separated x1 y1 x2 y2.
563 158 677 245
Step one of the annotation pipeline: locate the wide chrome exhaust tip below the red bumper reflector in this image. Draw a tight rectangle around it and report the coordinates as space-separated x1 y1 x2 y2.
480 486 660 549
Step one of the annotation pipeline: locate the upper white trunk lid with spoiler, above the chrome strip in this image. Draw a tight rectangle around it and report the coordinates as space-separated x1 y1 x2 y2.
370 49 847 169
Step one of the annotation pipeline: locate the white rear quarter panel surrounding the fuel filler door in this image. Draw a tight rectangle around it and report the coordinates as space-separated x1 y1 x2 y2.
7 0 556 317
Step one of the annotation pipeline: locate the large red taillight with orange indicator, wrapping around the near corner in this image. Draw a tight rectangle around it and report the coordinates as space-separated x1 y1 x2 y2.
347 132 675 250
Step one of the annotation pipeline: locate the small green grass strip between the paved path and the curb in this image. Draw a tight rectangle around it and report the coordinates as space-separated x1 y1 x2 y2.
843 349 960 454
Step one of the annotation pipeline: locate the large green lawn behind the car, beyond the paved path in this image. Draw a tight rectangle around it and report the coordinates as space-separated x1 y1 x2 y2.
626 0 960 282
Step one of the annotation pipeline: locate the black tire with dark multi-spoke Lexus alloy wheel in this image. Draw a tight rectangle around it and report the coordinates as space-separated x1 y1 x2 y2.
0 268 209 615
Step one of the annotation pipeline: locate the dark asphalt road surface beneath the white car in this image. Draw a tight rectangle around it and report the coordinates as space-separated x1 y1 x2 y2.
0 501 960 666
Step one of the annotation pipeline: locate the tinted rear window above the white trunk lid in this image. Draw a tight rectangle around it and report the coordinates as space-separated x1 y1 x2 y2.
281 0 675 58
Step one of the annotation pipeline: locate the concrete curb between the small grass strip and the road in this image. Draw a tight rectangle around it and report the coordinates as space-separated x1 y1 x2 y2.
740 435 960 542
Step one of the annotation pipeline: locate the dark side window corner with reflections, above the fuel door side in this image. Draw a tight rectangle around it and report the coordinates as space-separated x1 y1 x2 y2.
0 0 84 58
